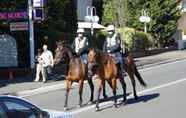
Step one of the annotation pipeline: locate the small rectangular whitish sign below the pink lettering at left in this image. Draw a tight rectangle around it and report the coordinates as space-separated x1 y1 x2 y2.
10 22 28 31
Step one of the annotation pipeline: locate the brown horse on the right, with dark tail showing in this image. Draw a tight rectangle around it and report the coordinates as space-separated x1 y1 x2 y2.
88 49 146 109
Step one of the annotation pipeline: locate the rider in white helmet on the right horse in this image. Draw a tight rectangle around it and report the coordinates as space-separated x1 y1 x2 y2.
103 25 125 76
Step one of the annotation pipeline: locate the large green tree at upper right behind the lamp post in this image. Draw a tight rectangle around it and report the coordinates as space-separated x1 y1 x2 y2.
127 0 180 47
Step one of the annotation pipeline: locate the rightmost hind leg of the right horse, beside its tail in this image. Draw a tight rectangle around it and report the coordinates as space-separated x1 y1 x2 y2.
128 69 138 100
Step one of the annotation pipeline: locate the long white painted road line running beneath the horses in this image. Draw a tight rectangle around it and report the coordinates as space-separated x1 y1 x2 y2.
71 78 186 114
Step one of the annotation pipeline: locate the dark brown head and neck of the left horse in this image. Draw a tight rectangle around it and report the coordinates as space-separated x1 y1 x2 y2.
54 42 73 65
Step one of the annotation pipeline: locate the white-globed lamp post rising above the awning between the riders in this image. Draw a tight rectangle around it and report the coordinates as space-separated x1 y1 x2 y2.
85 6 99 36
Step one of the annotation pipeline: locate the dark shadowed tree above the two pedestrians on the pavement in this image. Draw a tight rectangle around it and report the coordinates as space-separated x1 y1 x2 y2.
35 0 77 46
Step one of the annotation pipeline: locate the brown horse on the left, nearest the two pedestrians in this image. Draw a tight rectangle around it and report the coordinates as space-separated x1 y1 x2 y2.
54 42 94 110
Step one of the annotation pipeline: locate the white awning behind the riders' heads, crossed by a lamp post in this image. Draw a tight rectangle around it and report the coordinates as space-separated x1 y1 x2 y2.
78 22 105 29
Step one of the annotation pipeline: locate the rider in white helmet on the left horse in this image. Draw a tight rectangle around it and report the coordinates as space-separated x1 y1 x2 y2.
72 28 89 64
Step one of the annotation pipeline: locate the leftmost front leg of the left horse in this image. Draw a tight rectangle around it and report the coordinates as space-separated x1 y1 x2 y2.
64 79 72 111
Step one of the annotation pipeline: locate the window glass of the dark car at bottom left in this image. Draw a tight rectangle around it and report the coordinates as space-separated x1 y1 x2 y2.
4 100 39 118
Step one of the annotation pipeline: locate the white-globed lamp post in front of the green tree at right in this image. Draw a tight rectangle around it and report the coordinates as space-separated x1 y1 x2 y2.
139 9 150 33
